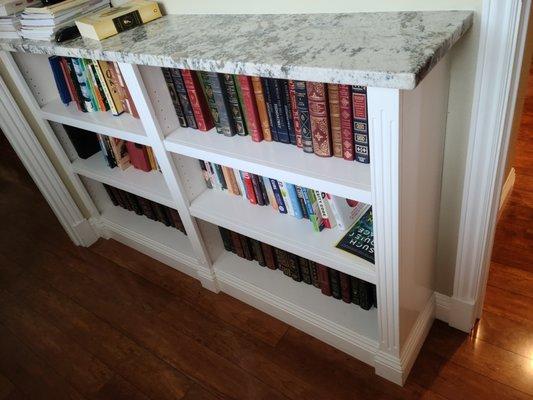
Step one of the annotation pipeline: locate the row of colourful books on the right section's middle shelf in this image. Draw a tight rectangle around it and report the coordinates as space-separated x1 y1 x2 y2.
199 160 370 232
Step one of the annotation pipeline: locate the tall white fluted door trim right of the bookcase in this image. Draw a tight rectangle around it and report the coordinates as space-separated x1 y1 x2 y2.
449 0 531 332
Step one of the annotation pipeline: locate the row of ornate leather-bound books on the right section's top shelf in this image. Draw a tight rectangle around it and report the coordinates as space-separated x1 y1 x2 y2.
162 68 370 163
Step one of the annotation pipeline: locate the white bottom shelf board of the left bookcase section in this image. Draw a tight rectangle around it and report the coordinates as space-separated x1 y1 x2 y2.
100 204 197 275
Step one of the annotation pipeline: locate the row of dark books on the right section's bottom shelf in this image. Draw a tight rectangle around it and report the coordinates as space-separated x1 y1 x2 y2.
219 227 377 310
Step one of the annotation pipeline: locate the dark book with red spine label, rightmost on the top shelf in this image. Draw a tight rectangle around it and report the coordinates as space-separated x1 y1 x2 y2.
352 86 370 164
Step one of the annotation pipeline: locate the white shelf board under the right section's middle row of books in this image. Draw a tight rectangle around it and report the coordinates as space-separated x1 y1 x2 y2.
190 189 376 283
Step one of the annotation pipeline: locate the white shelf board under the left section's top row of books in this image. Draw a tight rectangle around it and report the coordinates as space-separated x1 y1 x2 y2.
41 99 149 144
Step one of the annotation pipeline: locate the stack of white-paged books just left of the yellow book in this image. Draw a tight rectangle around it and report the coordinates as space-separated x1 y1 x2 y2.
20 0 110 41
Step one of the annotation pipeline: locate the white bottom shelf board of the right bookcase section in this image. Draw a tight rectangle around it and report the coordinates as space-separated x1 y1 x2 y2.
213 251 378 348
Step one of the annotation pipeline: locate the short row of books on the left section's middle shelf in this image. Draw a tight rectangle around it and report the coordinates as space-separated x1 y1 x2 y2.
63 125 160 172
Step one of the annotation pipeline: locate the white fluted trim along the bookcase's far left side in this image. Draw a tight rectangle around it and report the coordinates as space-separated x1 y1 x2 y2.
0 68 98 246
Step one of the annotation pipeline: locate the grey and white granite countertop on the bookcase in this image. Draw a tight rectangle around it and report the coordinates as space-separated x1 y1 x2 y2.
0 11 473 89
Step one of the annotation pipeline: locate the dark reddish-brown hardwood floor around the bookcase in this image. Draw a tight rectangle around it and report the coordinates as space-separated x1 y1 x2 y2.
0 74 533 400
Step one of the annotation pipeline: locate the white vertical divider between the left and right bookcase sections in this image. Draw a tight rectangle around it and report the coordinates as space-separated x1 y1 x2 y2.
119 63 219 292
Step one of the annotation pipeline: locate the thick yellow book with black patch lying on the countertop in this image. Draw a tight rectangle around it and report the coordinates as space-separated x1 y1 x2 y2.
76 0 161 40
